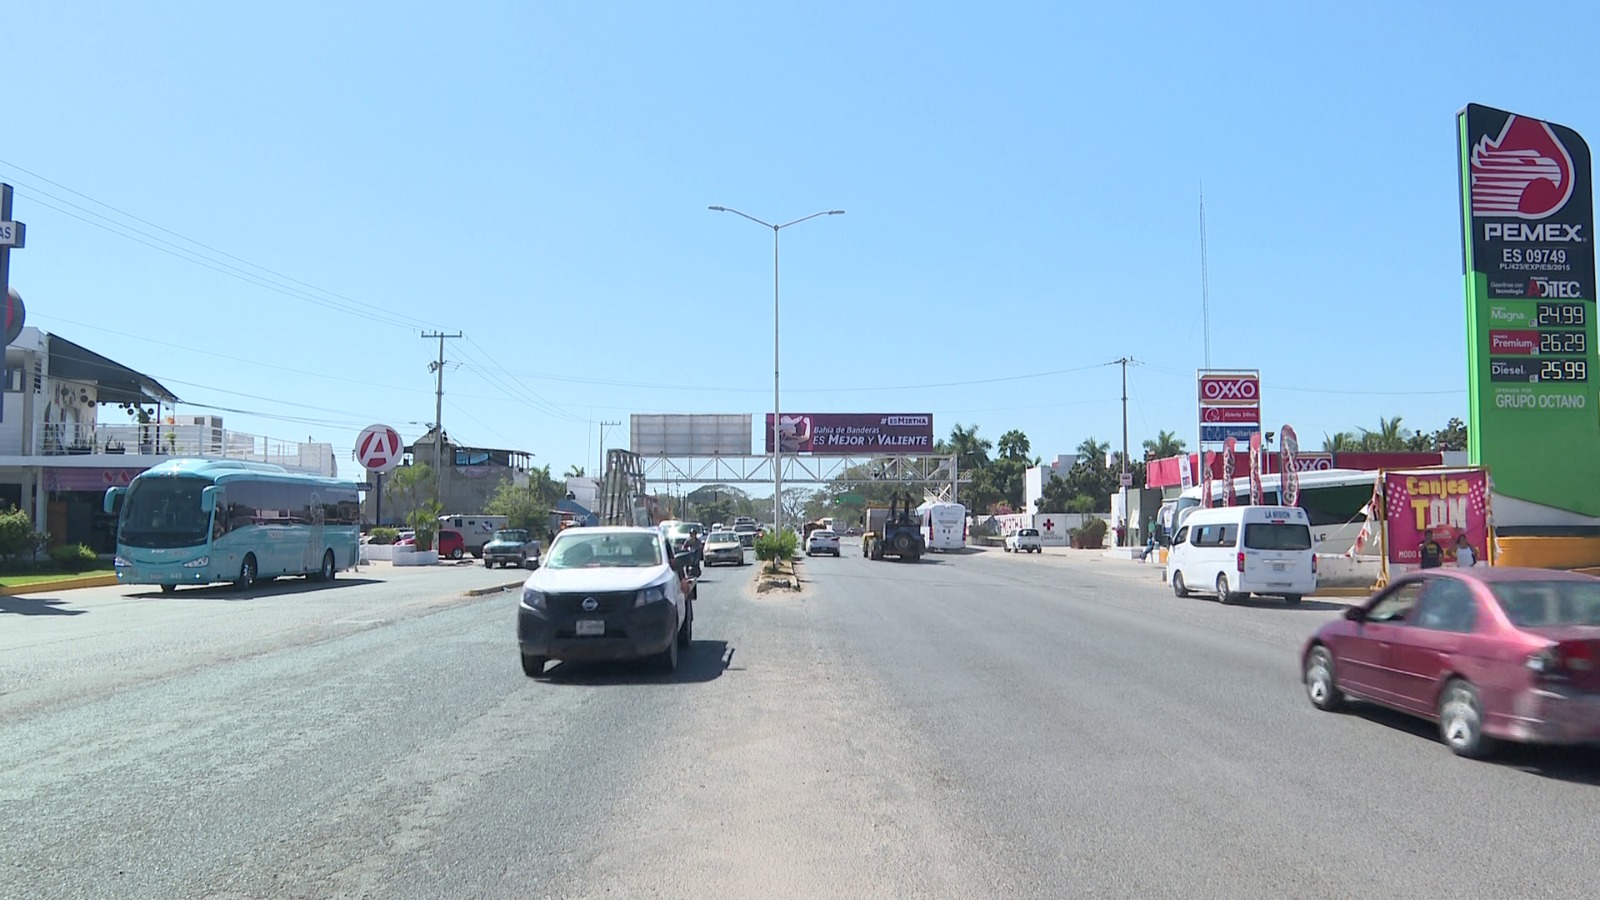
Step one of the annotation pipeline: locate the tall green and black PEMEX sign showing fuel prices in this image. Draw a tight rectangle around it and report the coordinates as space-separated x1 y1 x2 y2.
1456 104 1600 515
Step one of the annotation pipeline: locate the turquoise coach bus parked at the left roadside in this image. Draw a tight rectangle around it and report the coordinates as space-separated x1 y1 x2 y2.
104 460 362 594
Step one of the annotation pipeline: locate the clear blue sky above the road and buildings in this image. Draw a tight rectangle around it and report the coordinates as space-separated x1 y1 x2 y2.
0 2 1600 474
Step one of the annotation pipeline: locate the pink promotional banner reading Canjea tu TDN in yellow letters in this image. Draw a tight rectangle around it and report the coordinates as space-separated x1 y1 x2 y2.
1384 469 1488 565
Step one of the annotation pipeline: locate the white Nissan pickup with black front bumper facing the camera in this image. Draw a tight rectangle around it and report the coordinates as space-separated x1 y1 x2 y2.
517 527 698 677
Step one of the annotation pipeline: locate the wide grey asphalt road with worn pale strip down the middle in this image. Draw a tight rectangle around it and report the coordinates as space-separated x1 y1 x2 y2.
0 548 1600 898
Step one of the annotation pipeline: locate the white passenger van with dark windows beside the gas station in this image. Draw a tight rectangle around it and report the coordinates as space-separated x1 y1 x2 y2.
1166 506 1317 604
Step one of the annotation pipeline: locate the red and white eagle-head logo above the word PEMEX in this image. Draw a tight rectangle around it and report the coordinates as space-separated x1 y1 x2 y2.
1472 115 1574 219
